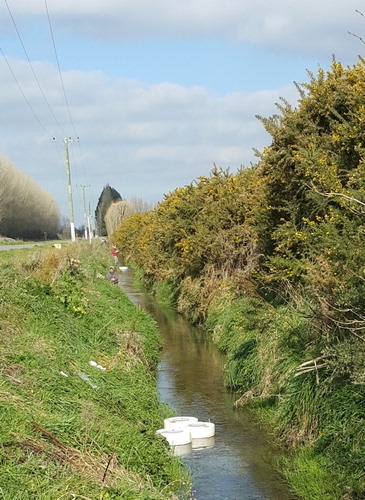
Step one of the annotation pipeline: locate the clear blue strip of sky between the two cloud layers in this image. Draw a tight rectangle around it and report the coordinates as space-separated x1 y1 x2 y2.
66 38 318 95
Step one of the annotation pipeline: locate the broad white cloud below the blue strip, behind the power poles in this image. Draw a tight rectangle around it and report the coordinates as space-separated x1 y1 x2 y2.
0 56 294 223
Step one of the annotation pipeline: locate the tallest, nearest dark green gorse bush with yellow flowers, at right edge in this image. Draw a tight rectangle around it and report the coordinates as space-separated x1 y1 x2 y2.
260 61 365 292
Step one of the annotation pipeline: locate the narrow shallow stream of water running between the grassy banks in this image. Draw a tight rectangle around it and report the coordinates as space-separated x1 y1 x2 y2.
120 270 294 500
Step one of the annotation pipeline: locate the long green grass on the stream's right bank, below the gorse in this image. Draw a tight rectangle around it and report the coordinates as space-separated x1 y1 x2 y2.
207 296 365 500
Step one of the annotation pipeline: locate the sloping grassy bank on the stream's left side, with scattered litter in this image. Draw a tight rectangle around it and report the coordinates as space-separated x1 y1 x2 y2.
0 242 187 500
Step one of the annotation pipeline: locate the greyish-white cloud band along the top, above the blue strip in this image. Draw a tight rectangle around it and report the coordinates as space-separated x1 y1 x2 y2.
0 0 365 56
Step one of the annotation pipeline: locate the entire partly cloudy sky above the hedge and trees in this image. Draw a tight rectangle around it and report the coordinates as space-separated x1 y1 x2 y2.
0 0 365 227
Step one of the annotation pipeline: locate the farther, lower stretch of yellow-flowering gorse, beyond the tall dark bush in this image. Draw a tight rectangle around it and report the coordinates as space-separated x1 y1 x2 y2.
113 168 263 317
